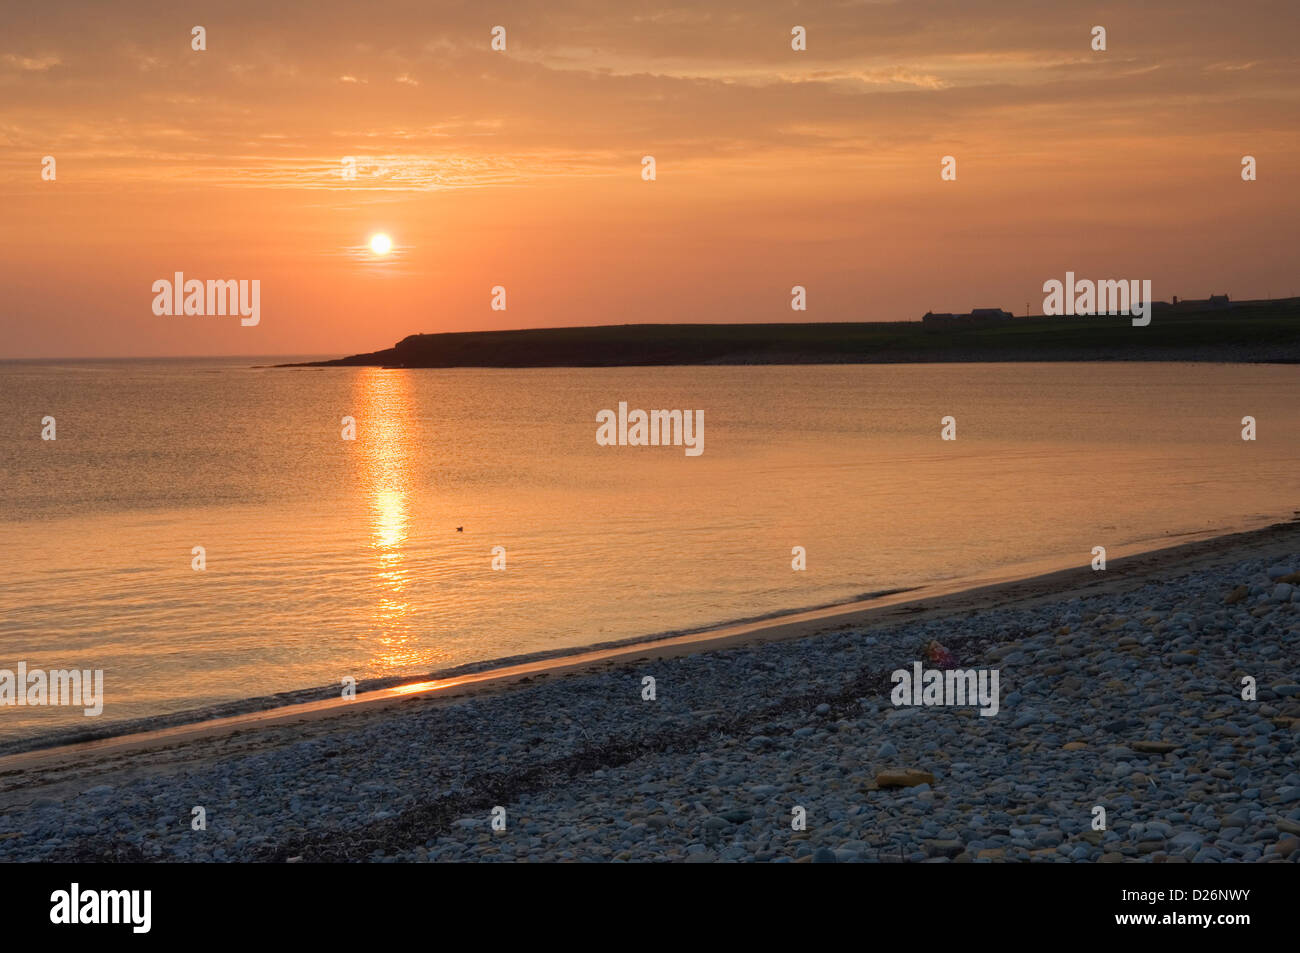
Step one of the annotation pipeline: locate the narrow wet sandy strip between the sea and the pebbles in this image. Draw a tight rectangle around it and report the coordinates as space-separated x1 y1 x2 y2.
0 517 1300 776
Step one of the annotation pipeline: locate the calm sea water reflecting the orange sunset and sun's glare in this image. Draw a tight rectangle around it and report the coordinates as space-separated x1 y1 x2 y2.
0 360 1300 738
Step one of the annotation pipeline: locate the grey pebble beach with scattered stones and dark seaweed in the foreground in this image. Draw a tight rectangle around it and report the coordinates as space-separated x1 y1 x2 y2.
0 541 1300 862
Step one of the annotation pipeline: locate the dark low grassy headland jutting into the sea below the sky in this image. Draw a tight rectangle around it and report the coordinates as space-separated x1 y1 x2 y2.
301 299 1300 367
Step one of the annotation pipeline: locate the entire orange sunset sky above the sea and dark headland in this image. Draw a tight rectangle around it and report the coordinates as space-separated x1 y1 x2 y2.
0 0 1300 359
